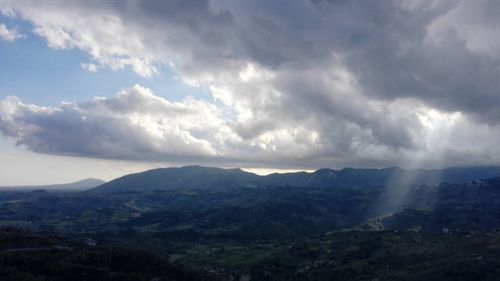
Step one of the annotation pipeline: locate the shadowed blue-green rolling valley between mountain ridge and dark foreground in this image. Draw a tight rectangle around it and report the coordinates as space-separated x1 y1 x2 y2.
4 174 500 242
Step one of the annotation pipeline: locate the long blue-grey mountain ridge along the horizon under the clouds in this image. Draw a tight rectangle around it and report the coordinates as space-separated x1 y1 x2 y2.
92 166 500 192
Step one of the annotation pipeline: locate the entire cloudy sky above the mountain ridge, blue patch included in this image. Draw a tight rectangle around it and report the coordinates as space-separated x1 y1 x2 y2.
0 0 500 185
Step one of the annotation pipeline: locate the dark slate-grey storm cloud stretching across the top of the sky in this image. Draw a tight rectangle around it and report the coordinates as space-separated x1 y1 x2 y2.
8 0 500 119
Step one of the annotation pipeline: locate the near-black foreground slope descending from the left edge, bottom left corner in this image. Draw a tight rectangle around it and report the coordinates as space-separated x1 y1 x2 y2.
0 229 217 281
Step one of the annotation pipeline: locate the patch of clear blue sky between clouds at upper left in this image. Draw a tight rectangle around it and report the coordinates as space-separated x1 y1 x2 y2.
0 16 212 106
